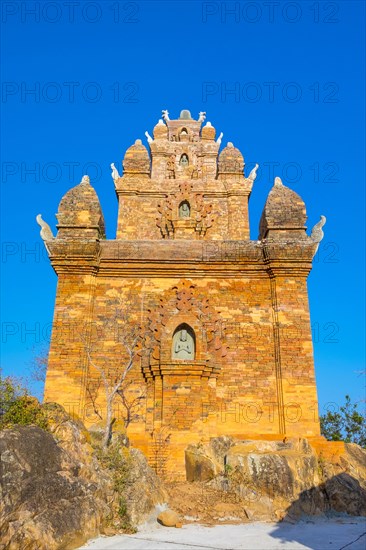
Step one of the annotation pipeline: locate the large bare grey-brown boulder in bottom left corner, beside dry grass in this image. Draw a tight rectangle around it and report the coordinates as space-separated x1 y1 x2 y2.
0 426 113 550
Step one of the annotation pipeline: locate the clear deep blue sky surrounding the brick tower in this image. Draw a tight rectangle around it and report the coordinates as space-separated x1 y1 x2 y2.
1 0 365 409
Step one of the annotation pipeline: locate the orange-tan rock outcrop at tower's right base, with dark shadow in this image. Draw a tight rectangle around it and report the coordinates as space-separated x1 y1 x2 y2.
183 437 366 520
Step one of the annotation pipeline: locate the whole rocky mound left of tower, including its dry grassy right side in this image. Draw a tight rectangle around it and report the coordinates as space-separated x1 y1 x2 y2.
0 403 165 550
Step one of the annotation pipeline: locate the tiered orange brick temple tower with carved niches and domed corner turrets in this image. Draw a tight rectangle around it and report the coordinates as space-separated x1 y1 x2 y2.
39 111 325 475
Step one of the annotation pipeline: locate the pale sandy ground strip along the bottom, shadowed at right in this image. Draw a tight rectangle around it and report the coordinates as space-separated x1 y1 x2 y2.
81 518 366 550
